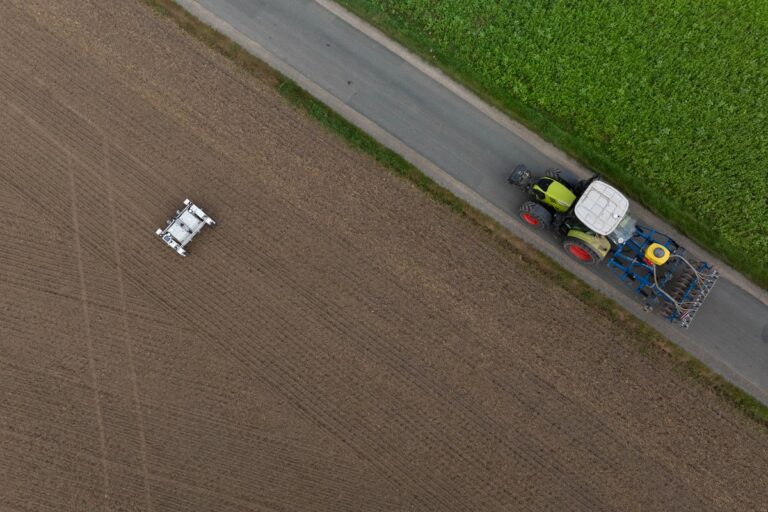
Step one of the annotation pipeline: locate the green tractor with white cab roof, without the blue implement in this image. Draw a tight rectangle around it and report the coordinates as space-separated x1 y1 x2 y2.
507 165 636 265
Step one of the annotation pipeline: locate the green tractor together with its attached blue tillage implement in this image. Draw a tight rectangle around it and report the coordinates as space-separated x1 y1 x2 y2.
508 165 720 329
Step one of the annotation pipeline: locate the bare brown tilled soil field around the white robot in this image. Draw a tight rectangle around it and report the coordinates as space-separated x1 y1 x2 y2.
0 0 768 512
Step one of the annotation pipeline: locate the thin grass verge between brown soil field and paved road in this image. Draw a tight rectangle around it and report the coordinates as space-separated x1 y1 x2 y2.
143 0 768 428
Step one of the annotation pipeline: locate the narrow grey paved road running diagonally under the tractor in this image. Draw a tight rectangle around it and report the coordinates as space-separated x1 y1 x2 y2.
177 0 768 403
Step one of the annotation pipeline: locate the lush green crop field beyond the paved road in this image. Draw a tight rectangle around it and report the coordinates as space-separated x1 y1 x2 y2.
340 0 768 287
